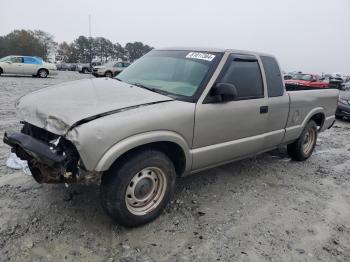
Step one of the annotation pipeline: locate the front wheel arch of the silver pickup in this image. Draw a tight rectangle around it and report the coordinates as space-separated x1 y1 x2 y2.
95 131 192 176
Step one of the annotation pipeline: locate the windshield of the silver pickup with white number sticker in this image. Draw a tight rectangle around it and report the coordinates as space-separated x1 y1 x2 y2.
117 50 221 98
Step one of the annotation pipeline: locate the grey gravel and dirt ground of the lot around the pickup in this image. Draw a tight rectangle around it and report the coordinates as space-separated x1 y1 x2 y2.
0 72 350 261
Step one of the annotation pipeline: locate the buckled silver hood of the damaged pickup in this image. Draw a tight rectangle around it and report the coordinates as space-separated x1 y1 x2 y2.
16 78 173 135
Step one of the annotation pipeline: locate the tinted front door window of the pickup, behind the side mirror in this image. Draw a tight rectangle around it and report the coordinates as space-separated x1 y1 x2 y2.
219 57 264 100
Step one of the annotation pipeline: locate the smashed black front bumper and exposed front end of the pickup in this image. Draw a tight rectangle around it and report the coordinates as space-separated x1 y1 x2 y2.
3 123 80 183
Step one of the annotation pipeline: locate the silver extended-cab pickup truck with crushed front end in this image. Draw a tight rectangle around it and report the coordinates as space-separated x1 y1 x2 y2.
4 48 338 226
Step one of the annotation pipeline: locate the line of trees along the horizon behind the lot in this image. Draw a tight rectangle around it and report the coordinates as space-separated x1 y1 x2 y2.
0 30 153 63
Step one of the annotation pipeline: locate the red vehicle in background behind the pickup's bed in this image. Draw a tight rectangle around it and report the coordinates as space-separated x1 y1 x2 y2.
285 74 329 90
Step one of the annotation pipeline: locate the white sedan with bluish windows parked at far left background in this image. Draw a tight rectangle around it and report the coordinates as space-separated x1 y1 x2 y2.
0 55 57 78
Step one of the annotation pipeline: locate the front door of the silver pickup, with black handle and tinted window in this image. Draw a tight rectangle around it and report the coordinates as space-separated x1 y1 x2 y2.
192 54 268 170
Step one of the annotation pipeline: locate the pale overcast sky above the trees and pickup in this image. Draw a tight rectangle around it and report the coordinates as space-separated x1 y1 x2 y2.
0 0 350 74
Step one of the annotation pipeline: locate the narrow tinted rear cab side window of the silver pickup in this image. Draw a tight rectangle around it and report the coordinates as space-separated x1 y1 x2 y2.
261 56 284 97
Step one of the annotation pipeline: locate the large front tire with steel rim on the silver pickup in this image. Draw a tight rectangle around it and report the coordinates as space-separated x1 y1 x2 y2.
100 149 176 227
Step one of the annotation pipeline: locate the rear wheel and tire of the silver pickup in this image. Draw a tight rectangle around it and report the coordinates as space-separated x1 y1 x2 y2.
287 120 317 161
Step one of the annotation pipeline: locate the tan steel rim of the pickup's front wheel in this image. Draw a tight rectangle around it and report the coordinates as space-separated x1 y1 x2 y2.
125 167 167 216
